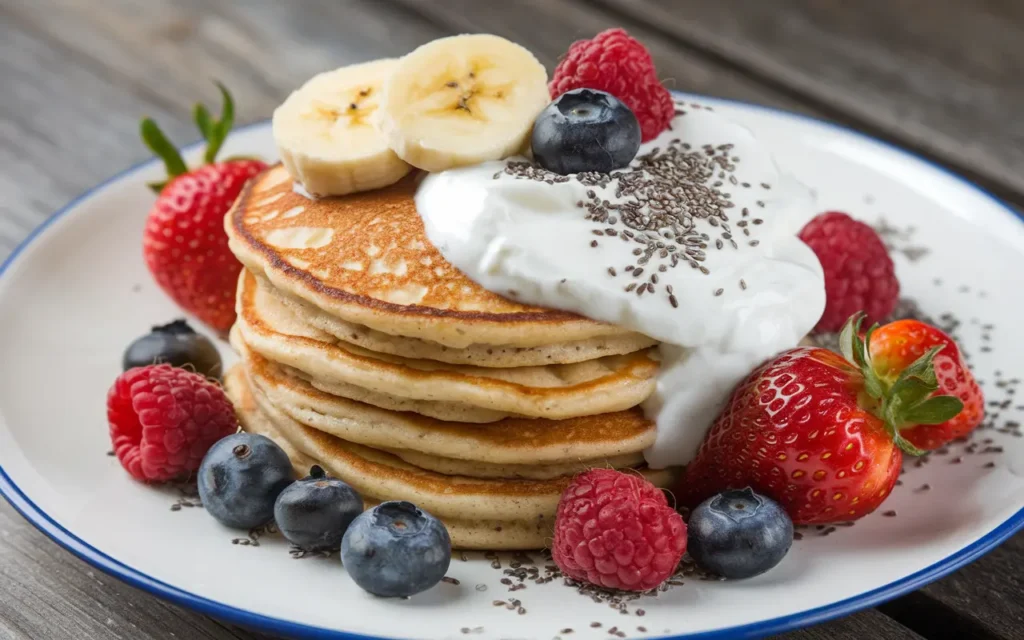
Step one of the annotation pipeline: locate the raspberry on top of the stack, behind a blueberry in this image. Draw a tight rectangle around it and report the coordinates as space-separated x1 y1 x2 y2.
548 29 676 142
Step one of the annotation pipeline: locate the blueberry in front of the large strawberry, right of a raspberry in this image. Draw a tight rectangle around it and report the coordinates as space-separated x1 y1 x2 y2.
686 488 793 579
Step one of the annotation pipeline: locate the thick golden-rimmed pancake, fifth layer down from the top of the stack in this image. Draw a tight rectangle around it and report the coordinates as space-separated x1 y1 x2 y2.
238 344 655 466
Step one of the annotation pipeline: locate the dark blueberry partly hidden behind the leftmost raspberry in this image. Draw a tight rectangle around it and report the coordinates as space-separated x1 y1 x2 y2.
121 319 221 378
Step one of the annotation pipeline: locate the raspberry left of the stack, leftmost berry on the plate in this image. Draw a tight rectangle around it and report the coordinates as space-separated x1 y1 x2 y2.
106 365 239 482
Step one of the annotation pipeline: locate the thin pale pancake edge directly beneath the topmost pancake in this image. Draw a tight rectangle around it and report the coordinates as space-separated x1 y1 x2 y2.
272 278 656 368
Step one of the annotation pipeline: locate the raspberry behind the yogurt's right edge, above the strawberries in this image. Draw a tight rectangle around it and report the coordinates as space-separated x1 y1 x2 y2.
800 211 899 331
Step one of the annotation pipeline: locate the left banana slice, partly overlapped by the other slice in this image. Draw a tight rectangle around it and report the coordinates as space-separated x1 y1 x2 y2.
273 59 412 196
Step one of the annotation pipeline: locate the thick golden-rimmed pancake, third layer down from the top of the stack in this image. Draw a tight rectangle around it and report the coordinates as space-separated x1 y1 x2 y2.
236 270 658 420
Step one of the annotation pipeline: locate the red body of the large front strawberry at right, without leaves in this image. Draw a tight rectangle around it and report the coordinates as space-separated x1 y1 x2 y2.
676 348 903 524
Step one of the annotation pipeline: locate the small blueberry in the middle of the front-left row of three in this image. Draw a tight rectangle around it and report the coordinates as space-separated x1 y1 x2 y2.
273 465 362 551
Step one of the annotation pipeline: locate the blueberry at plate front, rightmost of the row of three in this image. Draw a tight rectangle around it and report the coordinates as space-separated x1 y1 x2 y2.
341 502 452 598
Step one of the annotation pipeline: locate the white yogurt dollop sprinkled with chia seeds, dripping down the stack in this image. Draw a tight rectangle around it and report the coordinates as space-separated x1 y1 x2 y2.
416 103 825 468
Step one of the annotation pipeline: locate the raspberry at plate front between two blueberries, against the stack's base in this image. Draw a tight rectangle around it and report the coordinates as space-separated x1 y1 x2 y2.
551 469 686 591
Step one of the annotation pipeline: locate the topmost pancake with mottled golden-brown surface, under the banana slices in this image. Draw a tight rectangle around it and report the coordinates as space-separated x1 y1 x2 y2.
224 165 647 349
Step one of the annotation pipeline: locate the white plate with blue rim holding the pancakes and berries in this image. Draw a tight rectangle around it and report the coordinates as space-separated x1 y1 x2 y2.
0 94 1024 639
